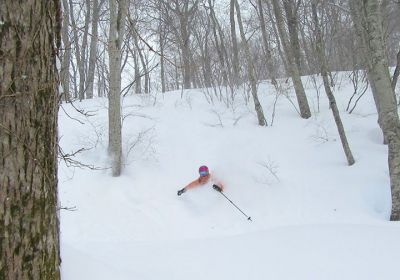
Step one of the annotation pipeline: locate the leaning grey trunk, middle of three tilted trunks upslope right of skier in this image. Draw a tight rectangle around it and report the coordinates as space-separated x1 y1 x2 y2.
272 0 311 119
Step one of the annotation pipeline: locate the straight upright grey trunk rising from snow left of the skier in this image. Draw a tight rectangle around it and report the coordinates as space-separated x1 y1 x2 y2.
108 0 127 176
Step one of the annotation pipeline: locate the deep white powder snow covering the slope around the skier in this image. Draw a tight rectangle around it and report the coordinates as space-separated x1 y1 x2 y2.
59 74 400 280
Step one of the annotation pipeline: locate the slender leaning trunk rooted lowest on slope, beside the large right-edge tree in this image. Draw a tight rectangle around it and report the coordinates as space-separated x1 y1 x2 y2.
311 0 355 165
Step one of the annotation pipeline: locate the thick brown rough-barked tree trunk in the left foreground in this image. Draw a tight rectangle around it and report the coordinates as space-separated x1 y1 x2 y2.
0 0 62 280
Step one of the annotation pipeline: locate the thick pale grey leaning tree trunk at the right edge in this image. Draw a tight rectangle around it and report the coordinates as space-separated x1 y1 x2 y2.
350 0 400 221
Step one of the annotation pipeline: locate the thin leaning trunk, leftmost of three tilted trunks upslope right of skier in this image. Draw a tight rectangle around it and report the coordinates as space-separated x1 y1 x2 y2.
235 0 268 126
